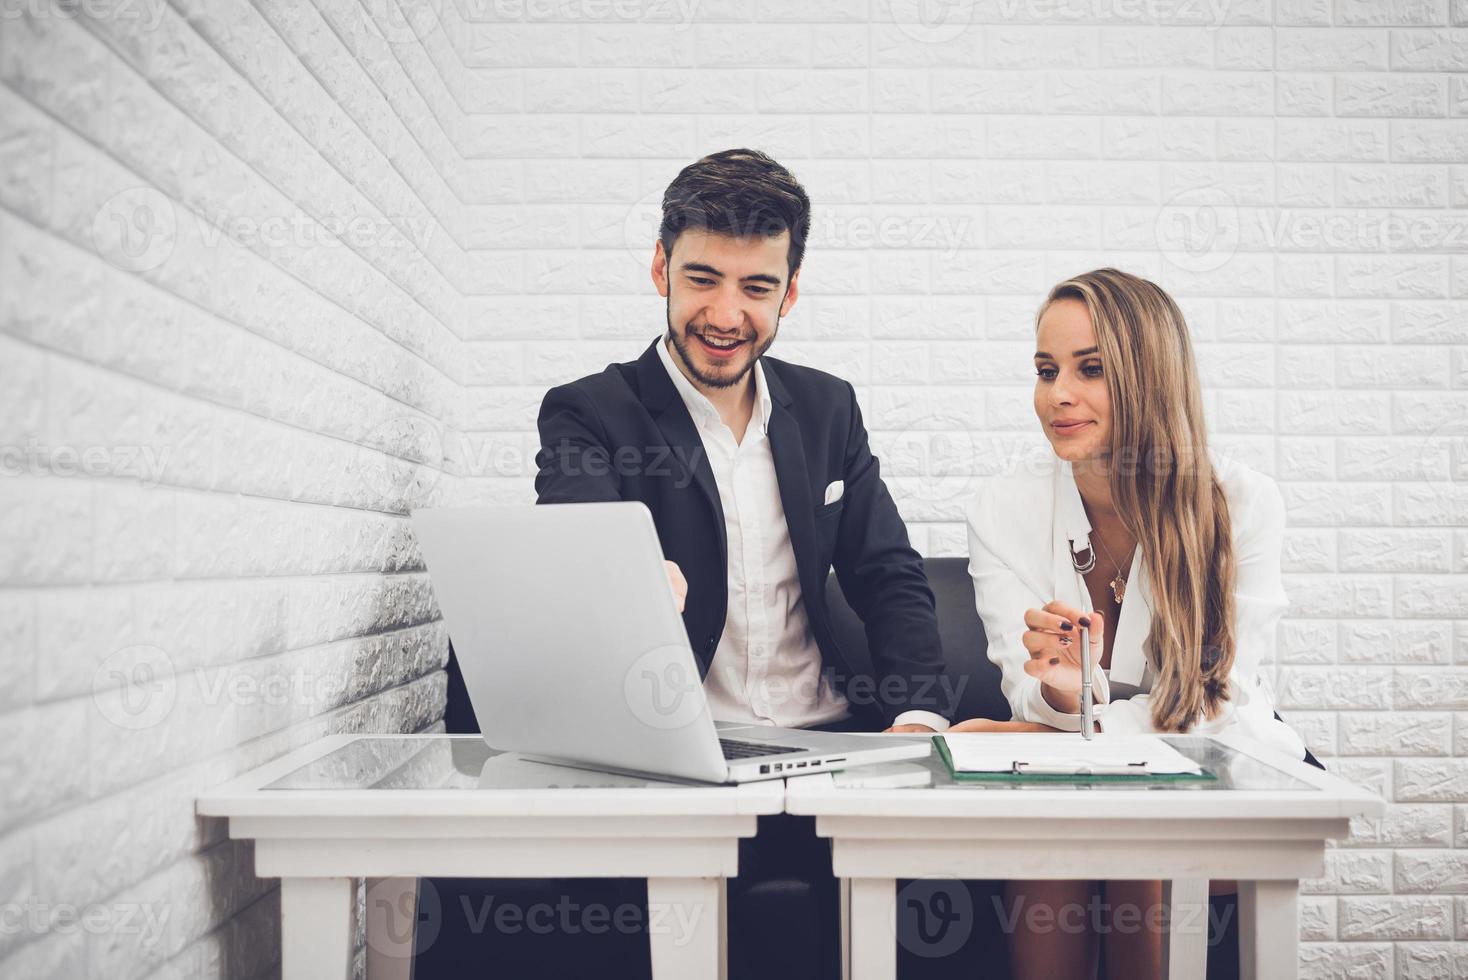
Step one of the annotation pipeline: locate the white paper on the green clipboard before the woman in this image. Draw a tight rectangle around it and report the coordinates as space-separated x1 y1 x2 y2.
942 732 1202 776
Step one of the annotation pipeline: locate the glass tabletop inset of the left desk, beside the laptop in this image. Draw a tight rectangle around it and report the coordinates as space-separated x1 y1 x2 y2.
261 735 690 791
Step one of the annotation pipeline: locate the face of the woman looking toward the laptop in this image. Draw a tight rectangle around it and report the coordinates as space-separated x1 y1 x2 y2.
1035 299 1111 462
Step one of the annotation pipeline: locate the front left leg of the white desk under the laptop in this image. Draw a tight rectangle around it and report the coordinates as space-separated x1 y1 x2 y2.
280 877 357 980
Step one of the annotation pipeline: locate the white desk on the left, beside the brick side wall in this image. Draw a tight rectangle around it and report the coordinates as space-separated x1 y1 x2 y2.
198 735 784 980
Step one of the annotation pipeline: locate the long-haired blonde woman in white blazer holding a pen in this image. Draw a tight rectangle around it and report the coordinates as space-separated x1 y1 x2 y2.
953 268 1312 979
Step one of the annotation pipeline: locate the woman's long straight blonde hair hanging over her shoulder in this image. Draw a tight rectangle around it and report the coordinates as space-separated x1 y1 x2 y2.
1039 268 1235 732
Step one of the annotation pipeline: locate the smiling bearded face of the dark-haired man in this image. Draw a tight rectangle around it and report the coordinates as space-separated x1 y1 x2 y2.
652 229 800 389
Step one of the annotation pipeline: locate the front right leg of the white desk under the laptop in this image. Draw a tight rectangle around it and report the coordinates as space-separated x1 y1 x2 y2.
647 877 728 980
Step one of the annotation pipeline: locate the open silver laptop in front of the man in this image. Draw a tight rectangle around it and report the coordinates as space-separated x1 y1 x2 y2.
413 502 931 782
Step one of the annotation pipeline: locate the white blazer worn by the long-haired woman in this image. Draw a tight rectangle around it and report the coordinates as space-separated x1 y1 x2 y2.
969 450 1305 758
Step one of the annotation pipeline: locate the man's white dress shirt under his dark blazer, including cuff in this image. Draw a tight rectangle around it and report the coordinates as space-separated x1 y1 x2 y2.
658 340 947 731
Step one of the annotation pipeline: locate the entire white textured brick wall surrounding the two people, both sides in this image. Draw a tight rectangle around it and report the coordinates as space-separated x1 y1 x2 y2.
0 0 1468 980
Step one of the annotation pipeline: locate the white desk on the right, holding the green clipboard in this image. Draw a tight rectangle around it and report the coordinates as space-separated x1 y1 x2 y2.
785 736 1384 980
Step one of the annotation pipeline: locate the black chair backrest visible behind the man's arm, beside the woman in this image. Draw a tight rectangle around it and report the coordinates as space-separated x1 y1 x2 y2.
826 557 1025 722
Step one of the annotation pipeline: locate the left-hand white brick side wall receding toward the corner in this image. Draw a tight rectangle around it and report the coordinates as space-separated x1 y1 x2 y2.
0 0 463 980
